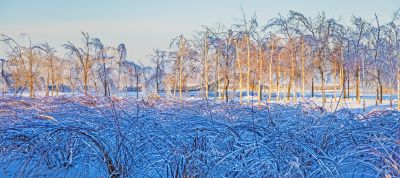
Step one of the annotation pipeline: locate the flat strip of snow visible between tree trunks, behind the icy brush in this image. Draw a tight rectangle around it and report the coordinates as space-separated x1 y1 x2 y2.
5 90 397 113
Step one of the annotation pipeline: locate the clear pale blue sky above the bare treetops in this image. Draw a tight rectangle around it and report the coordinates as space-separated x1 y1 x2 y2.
0 0 400 64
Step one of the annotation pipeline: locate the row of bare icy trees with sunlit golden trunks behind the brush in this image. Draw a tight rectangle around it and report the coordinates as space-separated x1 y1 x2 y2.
1 11 400 107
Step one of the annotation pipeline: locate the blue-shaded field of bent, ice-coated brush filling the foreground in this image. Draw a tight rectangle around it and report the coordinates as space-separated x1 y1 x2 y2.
0 96 400 177
